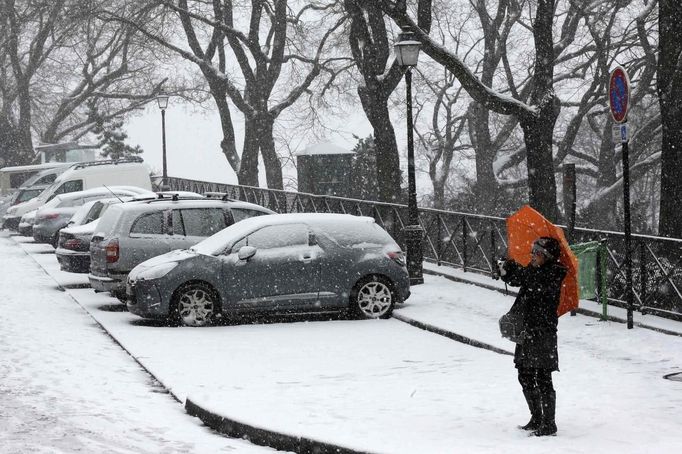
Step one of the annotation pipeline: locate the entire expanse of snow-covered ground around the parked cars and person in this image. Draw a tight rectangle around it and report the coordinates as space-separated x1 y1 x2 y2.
0 234 682 454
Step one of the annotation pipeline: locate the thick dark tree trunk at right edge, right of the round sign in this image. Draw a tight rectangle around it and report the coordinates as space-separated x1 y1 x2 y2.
657 0 682 238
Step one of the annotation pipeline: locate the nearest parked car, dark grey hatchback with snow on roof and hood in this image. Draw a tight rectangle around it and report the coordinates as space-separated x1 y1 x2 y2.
127 213 410 326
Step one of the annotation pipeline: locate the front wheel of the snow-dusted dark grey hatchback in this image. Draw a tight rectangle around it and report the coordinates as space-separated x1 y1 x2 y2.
171 282 218 326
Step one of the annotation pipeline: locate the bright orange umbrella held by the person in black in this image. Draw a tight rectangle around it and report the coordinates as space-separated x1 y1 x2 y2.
507 205 578 316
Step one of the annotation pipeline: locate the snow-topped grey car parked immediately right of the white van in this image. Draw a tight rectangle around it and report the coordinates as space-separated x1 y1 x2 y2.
33 186 154 248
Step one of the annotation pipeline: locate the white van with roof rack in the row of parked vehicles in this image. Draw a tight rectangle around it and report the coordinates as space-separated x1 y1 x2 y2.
3 158 152 229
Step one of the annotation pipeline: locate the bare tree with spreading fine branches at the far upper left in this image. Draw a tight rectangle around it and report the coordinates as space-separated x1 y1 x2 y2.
0 0 172 167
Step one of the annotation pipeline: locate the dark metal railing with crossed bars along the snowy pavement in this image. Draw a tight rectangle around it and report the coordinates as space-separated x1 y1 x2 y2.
168 178 682 321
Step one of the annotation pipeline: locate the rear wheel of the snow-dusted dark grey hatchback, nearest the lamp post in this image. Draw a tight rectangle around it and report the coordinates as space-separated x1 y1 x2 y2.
350 276 395 318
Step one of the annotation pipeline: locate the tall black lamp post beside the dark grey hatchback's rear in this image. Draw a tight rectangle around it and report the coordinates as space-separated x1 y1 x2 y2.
394 29 424 285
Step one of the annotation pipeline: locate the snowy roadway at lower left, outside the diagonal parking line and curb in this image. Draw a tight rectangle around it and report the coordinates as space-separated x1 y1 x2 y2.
0 233 274 454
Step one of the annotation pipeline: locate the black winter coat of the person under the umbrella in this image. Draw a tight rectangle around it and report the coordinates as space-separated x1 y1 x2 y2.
501 260 566 371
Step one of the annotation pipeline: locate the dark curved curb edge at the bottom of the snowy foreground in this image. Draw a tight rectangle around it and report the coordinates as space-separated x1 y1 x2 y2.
185 398 368 454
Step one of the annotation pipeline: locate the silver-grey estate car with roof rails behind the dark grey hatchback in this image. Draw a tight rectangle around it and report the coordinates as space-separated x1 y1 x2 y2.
88 196 273 299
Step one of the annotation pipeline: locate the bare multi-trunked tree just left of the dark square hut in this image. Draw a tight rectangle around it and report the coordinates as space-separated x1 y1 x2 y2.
112 0 345 189
